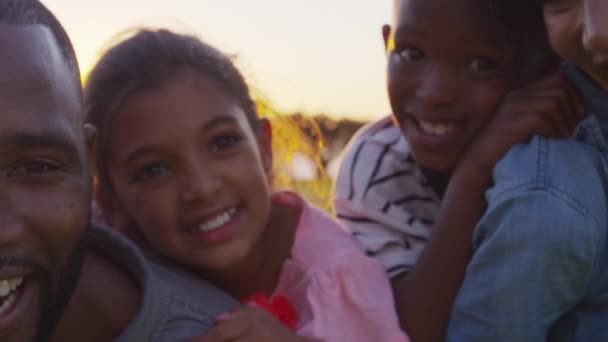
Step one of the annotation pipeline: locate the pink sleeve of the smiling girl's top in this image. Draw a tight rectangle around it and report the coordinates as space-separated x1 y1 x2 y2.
298 255 409 342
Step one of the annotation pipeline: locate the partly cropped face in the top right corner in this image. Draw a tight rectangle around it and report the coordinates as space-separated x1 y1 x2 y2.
543 0 608 90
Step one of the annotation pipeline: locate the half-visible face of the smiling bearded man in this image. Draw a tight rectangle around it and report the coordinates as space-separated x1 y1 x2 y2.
0 24 91 341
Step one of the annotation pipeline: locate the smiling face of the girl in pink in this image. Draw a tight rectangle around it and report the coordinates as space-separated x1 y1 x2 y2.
106 69 272 272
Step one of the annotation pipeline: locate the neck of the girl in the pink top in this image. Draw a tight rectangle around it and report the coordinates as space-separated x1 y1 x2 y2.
202 198 302 299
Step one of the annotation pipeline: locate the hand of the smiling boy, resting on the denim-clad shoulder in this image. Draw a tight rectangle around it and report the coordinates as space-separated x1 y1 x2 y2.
463 74 584 172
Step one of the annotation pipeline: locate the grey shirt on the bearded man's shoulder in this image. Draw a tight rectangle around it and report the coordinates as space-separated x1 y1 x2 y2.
90 228 238 341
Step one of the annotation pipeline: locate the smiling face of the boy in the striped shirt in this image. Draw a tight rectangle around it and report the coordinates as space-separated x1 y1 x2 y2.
384 0 524 172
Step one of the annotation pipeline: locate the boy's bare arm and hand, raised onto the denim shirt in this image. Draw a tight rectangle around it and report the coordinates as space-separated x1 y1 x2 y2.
393 75 582 341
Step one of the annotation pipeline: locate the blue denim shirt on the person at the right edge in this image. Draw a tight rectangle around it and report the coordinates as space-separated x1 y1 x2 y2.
446 66 608 342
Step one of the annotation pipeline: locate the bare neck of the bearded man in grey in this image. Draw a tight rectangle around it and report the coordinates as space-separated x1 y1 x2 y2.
52 251 142 342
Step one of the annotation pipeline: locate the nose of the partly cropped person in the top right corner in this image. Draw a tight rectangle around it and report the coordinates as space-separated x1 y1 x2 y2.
583 0 608 54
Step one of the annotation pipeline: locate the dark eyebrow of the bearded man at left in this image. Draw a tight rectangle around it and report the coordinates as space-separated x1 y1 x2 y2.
0 132 78 155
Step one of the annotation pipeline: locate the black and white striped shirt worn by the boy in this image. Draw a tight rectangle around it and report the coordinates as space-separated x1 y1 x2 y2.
334 116 439 277
